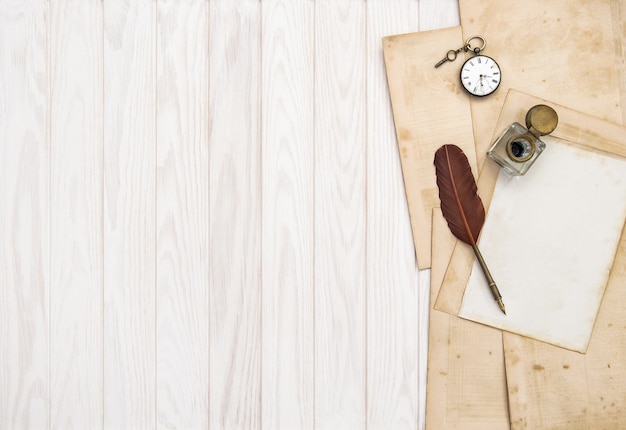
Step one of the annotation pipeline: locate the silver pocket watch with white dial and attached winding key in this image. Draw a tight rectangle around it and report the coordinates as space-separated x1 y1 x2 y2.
435 36 502 97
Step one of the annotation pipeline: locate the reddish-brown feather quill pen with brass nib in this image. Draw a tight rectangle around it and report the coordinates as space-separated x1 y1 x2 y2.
434 145 506 315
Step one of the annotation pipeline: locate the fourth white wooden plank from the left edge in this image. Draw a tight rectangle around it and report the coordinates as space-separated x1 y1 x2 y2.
156 0 209 428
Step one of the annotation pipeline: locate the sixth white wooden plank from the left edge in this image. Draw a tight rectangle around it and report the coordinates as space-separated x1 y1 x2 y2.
261 0 314 430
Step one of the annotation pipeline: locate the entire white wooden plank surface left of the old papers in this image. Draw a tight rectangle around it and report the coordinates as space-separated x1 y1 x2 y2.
0 0 458 430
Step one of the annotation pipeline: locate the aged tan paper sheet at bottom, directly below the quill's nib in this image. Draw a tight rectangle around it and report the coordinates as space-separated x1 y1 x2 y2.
426 208 509 430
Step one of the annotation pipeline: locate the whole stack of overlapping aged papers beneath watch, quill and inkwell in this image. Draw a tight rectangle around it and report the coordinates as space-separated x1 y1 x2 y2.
383 0 626 430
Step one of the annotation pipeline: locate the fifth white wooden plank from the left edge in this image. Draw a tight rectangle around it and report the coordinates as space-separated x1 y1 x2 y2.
209 0 261 429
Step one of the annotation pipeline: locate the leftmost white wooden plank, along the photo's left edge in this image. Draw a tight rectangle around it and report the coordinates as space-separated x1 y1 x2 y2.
0 1 50 429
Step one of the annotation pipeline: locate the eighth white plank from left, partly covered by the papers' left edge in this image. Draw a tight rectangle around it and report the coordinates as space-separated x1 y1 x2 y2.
366 0 426 429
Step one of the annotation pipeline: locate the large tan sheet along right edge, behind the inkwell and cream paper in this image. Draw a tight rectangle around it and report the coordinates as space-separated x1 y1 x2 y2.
459 0 626 424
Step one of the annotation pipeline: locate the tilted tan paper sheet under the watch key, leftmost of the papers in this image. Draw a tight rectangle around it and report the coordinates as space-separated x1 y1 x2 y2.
383 27 477 269
